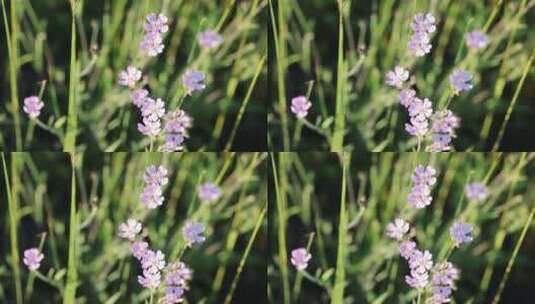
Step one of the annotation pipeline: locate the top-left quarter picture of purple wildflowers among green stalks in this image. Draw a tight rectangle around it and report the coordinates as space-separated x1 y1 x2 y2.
0 0 267 152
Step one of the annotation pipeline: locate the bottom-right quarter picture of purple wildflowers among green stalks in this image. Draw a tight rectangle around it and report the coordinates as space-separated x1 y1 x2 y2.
268 152 535 304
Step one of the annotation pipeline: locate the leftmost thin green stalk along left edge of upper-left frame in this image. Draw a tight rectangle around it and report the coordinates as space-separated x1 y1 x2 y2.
2 0 22 151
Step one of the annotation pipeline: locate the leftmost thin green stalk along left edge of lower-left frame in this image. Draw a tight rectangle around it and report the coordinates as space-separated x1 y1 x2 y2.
2 152 23 304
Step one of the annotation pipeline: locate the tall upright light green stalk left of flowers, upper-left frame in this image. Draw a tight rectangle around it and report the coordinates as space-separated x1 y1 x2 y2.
63 0 78 152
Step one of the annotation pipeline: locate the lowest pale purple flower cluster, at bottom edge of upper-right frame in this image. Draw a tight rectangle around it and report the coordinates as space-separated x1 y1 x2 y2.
428 110 460 152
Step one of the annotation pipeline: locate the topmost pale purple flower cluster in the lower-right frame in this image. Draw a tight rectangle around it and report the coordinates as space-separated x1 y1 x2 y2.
407 166 436 209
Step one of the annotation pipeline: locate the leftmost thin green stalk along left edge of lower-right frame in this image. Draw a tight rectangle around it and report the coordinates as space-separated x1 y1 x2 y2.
271 153 290 304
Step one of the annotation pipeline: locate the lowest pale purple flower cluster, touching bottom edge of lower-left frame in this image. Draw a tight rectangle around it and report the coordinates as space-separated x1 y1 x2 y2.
163 262 192 304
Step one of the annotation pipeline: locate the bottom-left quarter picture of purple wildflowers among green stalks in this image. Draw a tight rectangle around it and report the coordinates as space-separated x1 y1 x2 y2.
0 153 267 304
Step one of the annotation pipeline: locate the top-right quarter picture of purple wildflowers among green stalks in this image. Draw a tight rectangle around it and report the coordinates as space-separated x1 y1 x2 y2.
268 0 535 152
